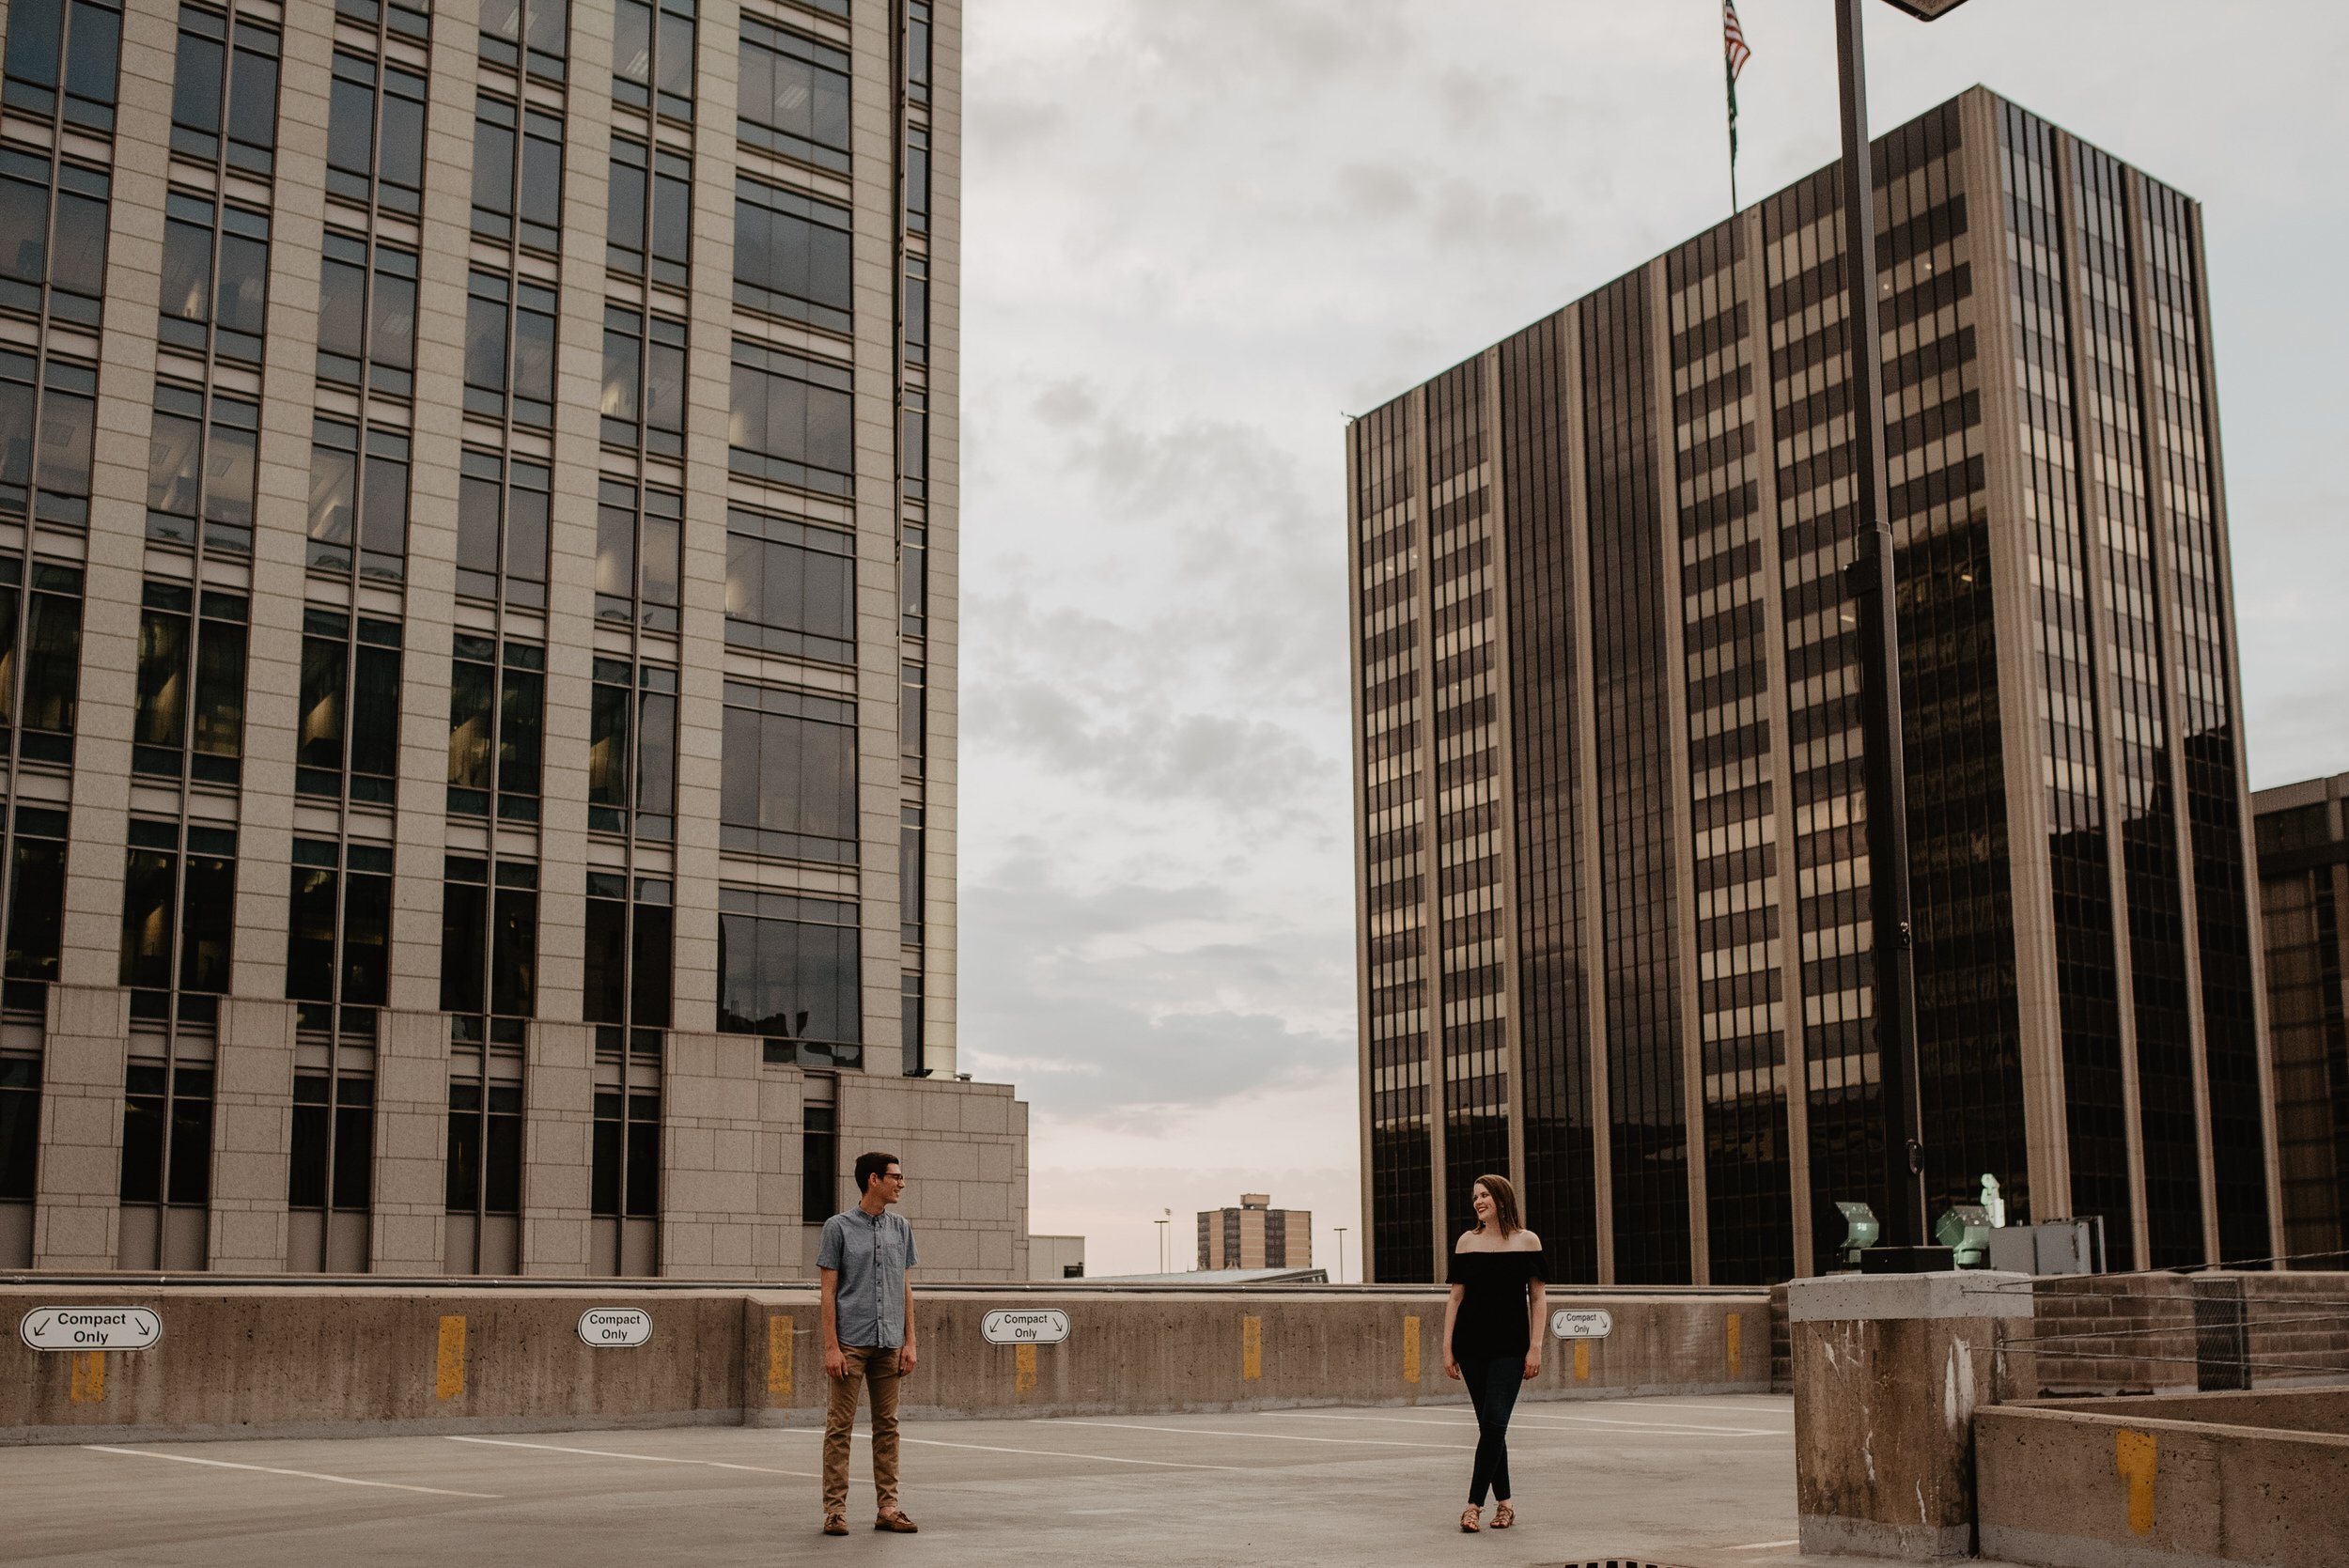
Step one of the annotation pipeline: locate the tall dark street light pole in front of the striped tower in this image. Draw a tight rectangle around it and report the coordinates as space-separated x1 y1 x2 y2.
1835 0 1952 1247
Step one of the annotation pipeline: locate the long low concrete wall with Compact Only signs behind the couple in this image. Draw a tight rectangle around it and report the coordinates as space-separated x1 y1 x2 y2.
0 1281 1769 1441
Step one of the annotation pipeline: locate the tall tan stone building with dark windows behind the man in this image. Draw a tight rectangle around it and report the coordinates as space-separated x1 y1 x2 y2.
0 0 1027 1280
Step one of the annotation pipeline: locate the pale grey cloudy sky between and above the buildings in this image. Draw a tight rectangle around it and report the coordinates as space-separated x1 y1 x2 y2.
961 0 2349 1277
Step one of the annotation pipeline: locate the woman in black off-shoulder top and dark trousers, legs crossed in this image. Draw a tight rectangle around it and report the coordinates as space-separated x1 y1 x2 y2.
1445 1176 1544 1533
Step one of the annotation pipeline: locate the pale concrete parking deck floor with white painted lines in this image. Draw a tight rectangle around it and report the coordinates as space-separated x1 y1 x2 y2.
0 1397 2020 1568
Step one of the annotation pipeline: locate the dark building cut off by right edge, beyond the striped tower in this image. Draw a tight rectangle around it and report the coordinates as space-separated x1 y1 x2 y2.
2250 772 2349 1270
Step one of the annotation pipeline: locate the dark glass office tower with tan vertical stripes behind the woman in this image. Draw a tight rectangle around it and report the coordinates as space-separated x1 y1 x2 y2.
1346 89 2277 1284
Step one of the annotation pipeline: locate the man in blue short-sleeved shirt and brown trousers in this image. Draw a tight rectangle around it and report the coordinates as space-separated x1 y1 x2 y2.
816 1153 921 1535
